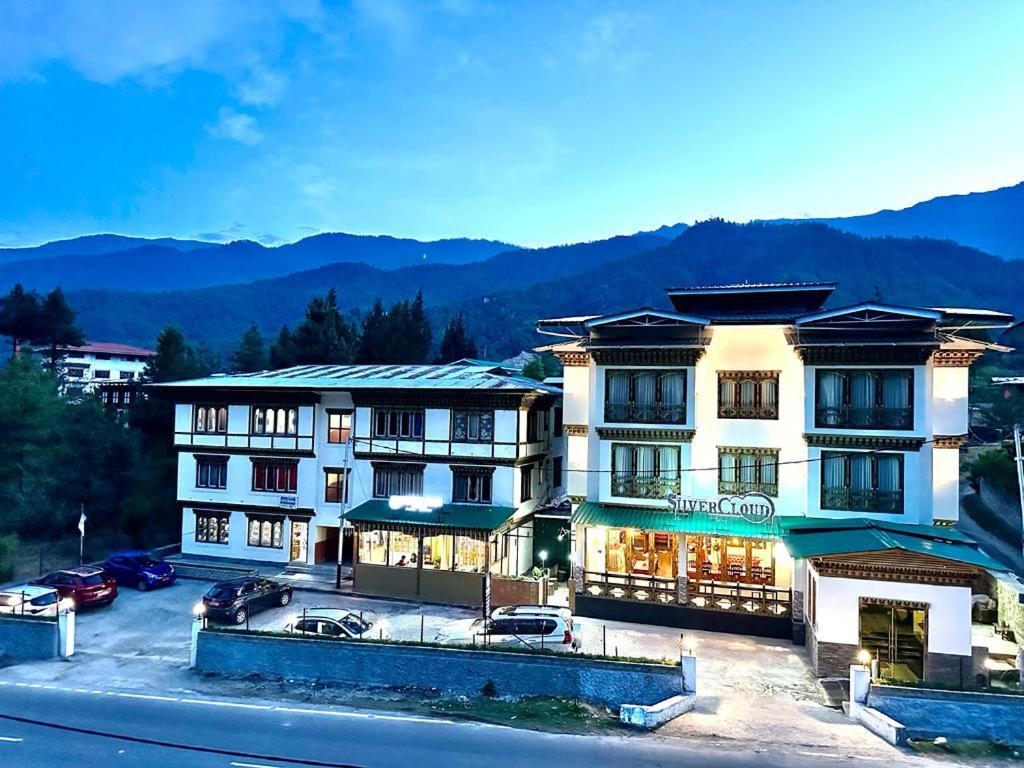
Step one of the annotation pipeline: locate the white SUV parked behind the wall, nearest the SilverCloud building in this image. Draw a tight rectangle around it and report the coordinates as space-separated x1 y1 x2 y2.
436 612 582 651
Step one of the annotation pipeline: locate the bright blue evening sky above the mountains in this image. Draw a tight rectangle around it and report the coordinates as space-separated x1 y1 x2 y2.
0 0 1024 246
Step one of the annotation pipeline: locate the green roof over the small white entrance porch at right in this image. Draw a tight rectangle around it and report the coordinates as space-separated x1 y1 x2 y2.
780 517 1007 571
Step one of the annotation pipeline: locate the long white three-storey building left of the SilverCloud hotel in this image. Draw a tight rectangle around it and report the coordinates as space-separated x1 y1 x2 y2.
157 360 563 605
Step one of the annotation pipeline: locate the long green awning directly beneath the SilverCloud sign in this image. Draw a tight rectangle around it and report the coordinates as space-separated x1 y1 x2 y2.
572 502 779 539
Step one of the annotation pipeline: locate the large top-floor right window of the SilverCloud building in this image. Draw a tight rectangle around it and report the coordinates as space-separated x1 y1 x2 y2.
814 369 913 429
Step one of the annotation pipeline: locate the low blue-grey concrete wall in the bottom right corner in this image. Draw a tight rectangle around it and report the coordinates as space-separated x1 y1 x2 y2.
867 685 1024 743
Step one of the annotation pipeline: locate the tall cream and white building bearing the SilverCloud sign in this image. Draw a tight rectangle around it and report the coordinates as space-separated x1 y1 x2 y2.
538 284 1012 680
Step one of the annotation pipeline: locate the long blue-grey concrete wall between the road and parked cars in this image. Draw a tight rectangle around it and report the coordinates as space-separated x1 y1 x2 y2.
196 630 683 707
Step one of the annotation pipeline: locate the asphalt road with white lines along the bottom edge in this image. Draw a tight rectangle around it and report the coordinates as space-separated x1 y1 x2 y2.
0 683 916 768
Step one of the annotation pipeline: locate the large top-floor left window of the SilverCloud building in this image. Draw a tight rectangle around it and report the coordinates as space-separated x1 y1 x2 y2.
604 371 686 424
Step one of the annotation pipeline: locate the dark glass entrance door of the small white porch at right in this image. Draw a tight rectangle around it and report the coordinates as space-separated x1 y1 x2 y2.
860 600 928 681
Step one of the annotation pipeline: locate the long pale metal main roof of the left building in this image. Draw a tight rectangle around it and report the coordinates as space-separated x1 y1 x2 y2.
155 360 561 394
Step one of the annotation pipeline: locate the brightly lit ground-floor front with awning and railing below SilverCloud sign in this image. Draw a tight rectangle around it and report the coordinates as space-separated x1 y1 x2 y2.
572 502 793 638
